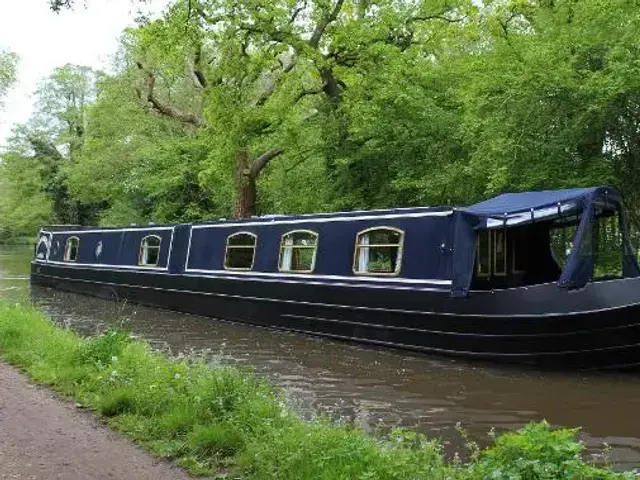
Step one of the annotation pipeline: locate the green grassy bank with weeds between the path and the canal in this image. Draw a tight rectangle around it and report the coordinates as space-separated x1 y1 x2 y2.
0 303 635 480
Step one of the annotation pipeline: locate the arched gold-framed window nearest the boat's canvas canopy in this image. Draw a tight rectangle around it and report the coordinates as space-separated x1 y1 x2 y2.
353 227 404 275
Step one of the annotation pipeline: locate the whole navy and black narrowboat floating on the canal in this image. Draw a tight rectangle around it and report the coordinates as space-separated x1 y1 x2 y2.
31 187 640 369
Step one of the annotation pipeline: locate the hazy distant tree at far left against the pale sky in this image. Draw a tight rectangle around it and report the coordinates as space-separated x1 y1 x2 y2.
0 65 99 231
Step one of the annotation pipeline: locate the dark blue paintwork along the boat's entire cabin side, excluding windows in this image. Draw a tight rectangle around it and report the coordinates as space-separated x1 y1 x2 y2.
42 208 454 281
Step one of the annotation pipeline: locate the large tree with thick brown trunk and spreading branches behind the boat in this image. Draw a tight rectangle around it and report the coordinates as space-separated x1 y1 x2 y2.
117 0 468 217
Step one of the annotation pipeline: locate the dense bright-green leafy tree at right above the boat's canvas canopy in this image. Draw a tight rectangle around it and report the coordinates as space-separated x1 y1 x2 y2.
455 0 640 206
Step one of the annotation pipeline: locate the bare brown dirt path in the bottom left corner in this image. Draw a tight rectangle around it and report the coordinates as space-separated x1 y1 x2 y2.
0 363 189 480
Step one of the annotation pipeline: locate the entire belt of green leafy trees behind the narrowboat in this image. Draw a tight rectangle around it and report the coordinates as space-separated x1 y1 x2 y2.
2 0 640 234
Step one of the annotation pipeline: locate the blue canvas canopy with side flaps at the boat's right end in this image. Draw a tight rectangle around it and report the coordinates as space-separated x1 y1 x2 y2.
452 187 640 296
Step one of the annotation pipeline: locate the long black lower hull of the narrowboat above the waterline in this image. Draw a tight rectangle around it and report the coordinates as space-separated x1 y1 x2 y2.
31 264 640 370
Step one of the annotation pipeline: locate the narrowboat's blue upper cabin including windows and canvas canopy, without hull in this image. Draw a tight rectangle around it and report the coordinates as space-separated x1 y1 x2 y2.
35 187 639 296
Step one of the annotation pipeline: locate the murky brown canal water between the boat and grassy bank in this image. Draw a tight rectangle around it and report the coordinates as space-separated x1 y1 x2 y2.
0 249 640 469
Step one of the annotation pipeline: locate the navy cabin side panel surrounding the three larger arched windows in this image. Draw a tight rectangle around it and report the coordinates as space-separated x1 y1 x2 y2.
187 216 453 280
